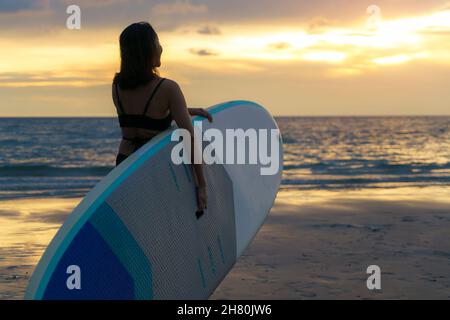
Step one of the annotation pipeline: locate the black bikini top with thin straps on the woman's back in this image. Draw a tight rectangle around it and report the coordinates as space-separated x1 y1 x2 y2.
115 78 172 132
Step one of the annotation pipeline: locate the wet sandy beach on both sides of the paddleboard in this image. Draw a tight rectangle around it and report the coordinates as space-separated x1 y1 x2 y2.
0 187 450 299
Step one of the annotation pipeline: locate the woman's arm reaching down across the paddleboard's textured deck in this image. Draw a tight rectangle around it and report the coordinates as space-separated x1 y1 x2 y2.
167 80 207 210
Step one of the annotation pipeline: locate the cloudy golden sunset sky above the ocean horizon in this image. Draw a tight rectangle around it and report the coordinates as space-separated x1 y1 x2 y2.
0 0 450 117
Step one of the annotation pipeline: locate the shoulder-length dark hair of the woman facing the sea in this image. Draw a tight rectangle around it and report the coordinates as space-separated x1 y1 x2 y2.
114 22 158 90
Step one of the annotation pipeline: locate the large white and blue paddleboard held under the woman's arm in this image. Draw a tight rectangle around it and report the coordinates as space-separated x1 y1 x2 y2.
25 101 283 299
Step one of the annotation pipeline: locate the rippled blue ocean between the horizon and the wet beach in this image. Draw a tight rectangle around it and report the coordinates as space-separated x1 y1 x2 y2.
0 117 450 201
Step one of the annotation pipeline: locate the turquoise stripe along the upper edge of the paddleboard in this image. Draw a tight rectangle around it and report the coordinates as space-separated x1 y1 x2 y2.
30 100 265 299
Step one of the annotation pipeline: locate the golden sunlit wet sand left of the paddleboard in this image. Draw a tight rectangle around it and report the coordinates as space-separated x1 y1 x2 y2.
0 198 80 299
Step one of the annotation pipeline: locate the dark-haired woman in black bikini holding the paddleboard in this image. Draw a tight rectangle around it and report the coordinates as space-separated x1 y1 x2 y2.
112 22 212 211
